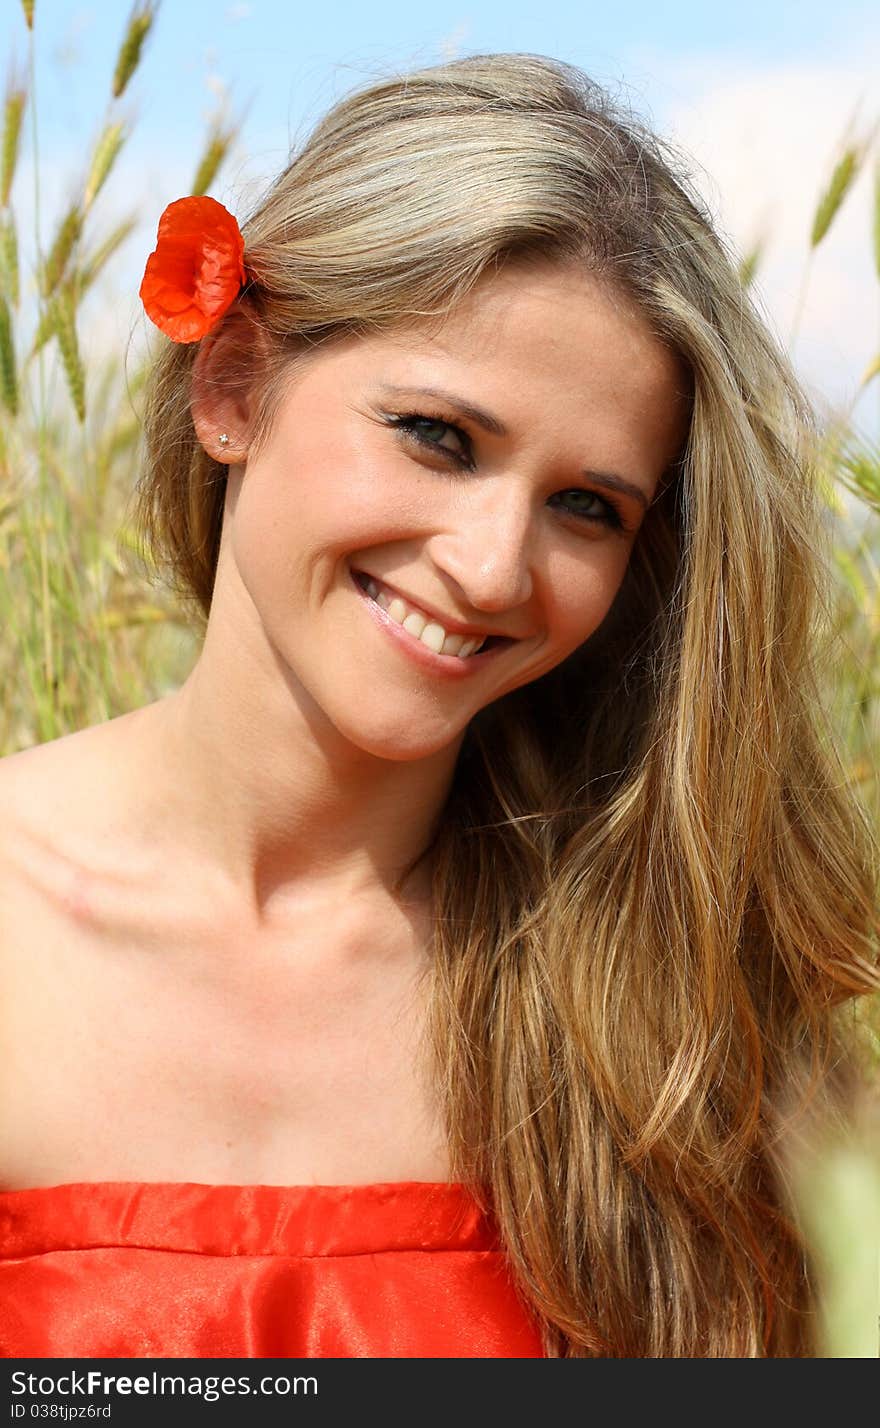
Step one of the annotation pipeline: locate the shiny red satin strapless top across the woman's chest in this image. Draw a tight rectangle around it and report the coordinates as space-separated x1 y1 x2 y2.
0 1181 543 1358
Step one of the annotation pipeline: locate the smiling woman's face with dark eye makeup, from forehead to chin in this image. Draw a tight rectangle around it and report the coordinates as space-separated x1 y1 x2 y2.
219 267 687 760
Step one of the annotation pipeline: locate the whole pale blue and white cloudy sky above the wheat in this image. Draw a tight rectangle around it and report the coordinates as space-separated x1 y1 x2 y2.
6 0 880 445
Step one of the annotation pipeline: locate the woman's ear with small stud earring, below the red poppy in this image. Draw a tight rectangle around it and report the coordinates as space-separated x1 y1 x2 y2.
190 306 267 466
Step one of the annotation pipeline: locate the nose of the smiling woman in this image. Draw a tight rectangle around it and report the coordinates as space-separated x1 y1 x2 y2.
429 483 534 614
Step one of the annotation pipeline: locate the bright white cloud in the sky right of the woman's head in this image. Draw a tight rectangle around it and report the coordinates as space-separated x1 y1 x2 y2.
630 39 880 436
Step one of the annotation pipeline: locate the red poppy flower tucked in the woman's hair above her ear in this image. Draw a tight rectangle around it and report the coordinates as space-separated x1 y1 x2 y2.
140 197 246 343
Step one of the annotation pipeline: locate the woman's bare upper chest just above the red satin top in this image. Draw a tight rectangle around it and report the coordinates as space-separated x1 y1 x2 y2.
0 851 449 1188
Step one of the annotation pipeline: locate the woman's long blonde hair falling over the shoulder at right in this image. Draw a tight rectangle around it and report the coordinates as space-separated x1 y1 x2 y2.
137 54 880 1358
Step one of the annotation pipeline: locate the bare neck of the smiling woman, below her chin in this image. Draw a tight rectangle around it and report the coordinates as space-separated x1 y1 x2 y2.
137 585 461 925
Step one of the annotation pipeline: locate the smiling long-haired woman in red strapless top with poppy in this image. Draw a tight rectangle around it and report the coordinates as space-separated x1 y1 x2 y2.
1 54 880 1357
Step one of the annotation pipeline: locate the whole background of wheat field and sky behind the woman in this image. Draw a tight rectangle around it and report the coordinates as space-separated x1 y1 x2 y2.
0 0 880 1357
